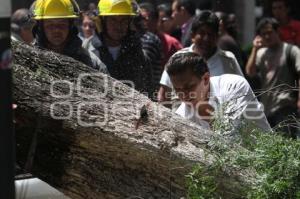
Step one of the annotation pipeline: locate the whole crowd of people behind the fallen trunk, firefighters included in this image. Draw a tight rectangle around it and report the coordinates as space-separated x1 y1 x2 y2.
11 0 300 138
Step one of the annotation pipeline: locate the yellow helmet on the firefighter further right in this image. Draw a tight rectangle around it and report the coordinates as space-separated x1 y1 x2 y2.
98 0 135 16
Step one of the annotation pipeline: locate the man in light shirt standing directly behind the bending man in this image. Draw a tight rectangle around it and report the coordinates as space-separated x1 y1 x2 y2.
158 11 243 102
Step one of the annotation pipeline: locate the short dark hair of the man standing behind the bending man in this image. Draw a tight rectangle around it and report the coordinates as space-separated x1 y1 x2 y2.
191 10 219 34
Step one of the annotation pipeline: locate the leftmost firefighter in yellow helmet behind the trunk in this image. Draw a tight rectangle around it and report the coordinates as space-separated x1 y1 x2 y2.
32 0 106 72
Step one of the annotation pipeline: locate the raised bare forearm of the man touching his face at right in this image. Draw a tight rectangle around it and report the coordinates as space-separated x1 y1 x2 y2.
246 36 263 77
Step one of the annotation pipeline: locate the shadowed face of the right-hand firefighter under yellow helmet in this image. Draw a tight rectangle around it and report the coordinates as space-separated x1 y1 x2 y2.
106 16 130 42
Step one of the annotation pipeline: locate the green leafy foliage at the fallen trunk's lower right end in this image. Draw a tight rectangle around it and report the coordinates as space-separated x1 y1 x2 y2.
187 124 300 199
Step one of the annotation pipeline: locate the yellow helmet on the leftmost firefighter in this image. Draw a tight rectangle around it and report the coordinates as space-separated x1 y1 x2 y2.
33 0 79 20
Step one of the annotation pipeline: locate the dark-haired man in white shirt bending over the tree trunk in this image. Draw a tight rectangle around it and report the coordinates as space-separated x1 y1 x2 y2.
166 52 271 134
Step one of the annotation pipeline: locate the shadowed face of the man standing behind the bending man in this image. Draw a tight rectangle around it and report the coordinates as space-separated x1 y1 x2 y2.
192 25 218 59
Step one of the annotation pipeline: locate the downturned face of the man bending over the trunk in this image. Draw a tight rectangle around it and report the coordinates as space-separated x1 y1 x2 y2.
170 70 210 107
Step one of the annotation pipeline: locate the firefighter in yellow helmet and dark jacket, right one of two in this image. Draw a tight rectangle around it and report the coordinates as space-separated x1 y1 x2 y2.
91 0 153 96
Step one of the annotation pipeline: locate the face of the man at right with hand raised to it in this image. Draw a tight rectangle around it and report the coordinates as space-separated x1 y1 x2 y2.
259 24 279 47
